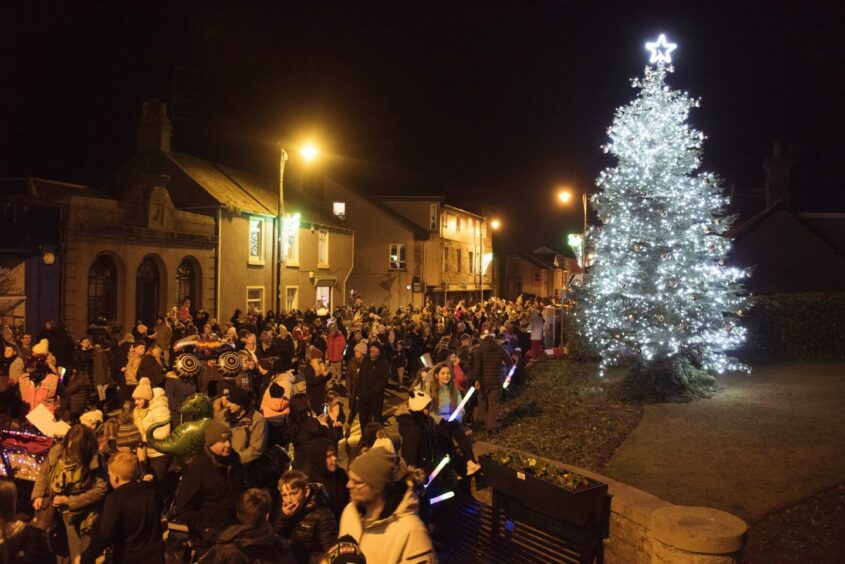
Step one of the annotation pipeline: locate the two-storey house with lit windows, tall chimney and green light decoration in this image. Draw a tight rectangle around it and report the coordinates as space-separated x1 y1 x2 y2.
109 102 354 320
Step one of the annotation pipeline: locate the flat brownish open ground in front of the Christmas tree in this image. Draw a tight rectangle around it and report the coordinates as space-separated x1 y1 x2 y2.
604 362 845 524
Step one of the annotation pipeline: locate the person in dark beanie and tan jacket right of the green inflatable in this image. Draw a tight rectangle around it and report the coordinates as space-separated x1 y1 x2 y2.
215 386 268 470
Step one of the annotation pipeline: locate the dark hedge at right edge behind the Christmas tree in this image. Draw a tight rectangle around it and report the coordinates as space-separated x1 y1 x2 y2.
736 293 845 362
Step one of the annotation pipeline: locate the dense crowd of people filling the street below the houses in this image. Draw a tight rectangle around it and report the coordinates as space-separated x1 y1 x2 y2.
0 299 544 564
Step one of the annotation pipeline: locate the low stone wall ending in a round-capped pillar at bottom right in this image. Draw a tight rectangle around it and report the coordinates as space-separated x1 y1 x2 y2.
475 442 748 564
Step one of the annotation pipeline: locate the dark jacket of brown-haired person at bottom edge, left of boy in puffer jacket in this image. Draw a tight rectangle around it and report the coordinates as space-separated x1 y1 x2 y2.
202 523 296 564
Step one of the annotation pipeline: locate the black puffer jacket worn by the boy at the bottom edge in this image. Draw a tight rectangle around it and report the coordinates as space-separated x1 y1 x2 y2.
276 483 337 564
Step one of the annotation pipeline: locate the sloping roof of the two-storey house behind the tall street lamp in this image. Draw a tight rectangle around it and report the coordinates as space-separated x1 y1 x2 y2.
166 152 348 230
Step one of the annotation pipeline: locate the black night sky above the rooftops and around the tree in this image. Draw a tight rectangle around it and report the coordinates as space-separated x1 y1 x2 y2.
0 0 845 250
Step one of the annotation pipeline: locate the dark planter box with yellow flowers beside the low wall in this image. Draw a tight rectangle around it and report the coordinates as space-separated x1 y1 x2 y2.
479 455 610 536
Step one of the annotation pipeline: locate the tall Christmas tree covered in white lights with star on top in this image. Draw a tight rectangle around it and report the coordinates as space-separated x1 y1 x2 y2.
580 35 746 395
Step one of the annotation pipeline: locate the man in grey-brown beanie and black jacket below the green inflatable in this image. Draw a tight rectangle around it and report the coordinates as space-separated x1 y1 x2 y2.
173 420 243 549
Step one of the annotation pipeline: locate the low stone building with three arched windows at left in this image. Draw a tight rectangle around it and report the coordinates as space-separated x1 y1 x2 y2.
2 175 217 338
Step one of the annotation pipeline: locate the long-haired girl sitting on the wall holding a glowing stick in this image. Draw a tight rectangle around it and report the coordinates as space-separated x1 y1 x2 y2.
428 362 481 476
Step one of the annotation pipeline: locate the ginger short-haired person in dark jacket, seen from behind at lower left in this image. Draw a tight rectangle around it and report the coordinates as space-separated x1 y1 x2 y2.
82 452 164 564
